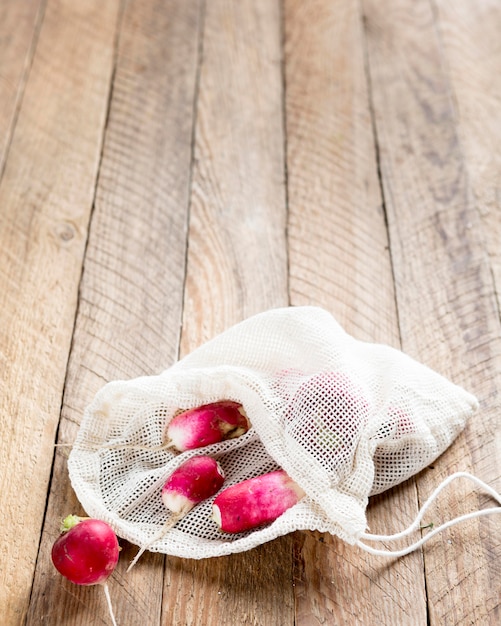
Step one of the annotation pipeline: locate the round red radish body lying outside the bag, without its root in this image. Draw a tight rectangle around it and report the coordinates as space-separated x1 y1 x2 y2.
51 515 120 585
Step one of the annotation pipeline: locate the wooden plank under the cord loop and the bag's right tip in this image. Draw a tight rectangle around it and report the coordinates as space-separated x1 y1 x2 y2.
363 0 501 626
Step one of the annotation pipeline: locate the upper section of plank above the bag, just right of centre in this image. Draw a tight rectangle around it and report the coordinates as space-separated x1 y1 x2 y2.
285 0 399 345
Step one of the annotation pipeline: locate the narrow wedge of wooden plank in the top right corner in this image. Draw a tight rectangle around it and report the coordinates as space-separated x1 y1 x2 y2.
434 0 501 330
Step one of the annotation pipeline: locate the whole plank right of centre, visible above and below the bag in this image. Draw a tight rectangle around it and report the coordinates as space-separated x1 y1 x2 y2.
285 0 426 626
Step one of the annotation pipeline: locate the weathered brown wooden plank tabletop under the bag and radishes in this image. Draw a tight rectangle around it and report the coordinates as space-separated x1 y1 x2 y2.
0 0 501 626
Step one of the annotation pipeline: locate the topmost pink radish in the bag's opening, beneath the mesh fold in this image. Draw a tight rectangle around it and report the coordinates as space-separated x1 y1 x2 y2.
165 400 250 452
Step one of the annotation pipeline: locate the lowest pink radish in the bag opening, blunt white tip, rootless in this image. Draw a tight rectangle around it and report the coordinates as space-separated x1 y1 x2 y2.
212 470 305 533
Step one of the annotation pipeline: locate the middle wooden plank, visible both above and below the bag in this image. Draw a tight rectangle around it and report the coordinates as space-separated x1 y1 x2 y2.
163 0 294 626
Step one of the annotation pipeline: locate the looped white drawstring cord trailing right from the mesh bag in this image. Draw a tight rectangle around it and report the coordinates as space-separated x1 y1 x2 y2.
356 472 501 557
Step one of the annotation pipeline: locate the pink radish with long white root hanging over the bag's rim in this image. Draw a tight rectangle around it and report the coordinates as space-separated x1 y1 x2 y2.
127 455 224 572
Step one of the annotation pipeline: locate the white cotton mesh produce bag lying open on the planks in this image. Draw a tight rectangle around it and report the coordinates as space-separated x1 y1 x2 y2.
68 307 501 558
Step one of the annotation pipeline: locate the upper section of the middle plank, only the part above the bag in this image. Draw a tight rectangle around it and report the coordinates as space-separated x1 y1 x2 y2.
182 0 288 353
